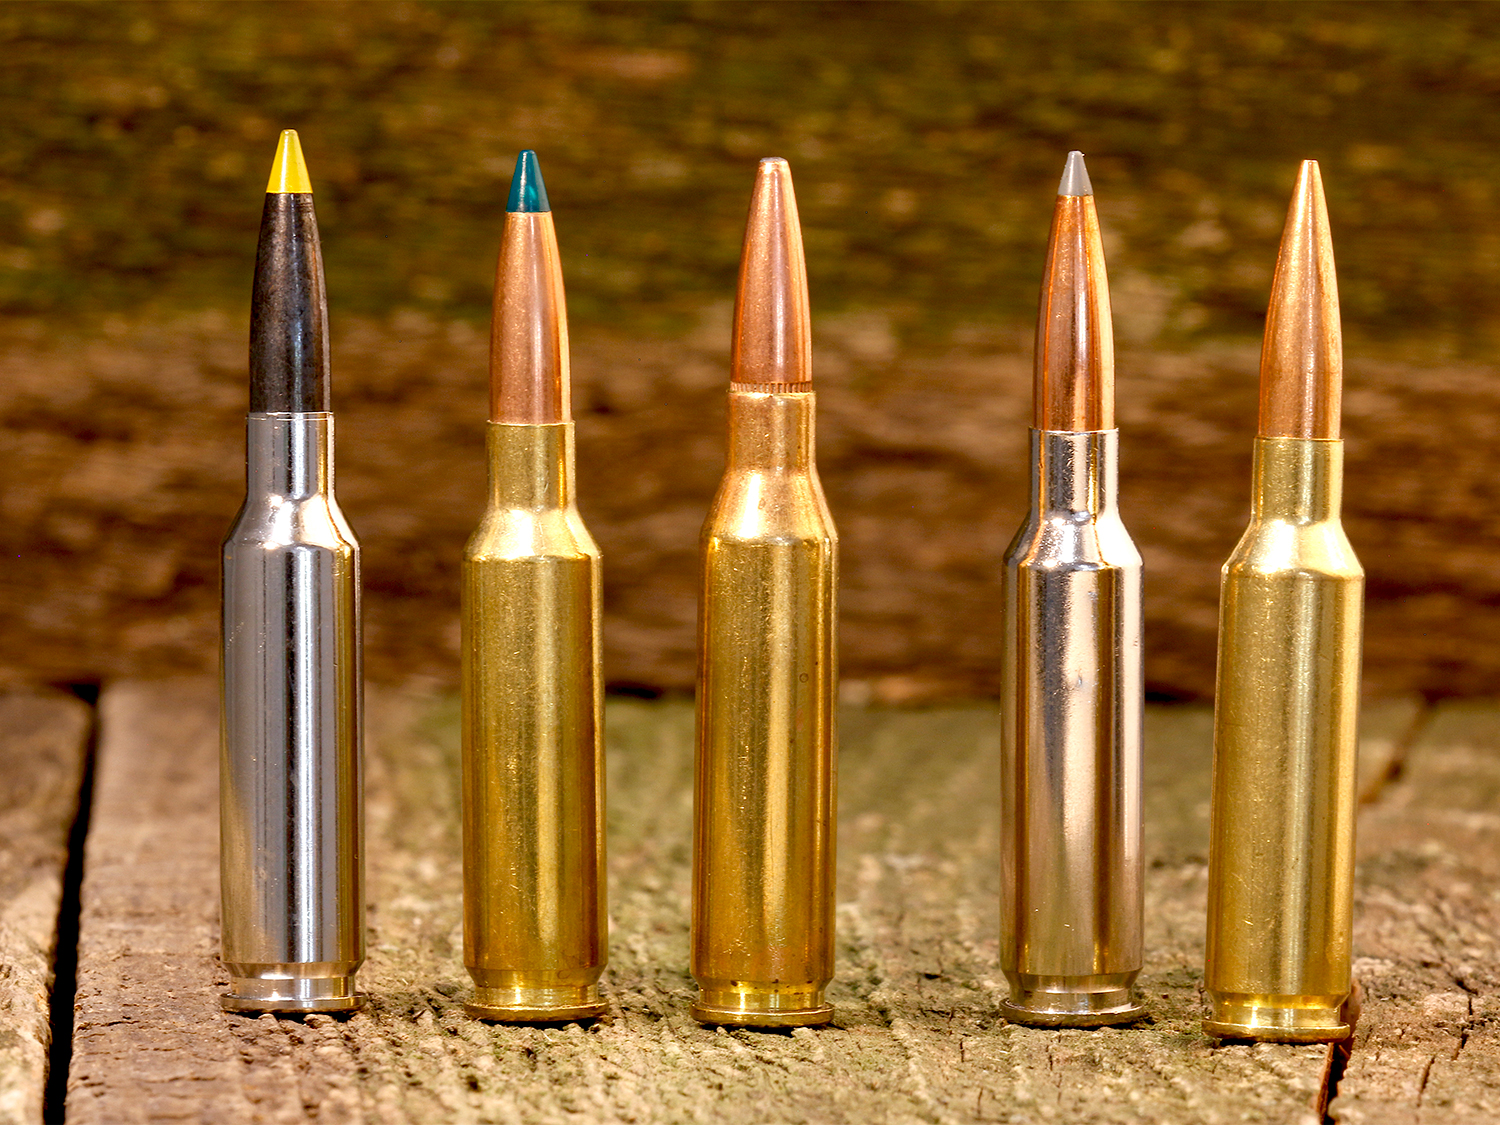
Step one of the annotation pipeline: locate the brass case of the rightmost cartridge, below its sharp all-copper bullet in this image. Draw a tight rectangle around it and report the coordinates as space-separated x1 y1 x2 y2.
1205 438 1364 1041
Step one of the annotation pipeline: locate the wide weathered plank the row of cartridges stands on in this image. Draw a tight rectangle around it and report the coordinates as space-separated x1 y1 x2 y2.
55 683 1439 1125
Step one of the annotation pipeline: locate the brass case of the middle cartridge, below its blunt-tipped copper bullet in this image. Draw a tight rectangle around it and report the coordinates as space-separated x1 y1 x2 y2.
692 390 839 1028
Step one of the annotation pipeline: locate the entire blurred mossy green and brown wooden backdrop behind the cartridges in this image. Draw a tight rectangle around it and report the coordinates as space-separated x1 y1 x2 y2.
0 3 1500 701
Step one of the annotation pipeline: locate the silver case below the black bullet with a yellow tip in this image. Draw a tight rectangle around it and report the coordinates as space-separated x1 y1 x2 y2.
219 413 365 1013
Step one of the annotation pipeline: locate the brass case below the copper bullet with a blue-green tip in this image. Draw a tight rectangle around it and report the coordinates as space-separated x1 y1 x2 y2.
462 422 608 1022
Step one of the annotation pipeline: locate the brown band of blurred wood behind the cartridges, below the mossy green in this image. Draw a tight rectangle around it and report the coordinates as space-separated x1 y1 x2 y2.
0 318 1500 702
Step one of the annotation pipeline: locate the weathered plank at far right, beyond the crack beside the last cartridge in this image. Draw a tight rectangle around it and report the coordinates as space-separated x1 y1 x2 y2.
1331 702 1500 1125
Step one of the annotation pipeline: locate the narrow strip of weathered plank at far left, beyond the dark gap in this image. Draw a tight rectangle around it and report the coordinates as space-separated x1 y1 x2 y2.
0 693 92 1125
